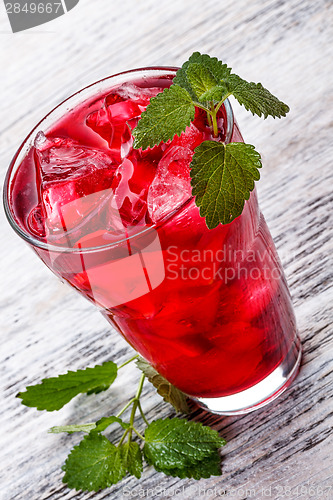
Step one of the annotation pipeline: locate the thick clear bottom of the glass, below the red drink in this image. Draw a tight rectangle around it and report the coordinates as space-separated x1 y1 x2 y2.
191 337 302 415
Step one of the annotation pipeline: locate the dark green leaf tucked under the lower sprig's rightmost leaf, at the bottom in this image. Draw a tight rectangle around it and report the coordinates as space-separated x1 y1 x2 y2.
155 451 222 479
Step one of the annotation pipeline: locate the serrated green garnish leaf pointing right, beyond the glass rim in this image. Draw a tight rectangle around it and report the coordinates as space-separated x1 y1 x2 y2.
226 75 289 118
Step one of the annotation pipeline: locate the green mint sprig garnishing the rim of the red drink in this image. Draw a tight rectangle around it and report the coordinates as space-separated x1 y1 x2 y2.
133 52 289 229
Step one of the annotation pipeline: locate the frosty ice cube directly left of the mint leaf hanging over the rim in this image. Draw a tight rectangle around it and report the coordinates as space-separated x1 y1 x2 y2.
147 146 193 222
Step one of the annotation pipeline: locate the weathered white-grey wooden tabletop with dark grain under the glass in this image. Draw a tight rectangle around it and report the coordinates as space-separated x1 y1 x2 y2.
0 0 333 500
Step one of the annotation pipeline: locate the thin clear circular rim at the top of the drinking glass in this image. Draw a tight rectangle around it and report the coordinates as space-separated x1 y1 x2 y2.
3 66 234 253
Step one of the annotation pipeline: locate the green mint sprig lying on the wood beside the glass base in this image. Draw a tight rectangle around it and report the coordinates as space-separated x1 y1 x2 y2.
19 355 225 491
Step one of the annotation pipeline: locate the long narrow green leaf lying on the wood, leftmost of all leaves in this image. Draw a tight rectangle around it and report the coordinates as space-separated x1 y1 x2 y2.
17 361 117 411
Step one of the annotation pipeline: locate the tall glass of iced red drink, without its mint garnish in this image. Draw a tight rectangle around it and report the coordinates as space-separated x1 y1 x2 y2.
4 68 301 415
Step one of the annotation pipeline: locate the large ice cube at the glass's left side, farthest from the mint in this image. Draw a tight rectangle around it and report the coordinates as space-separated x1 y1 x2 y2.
35 132 115 235
